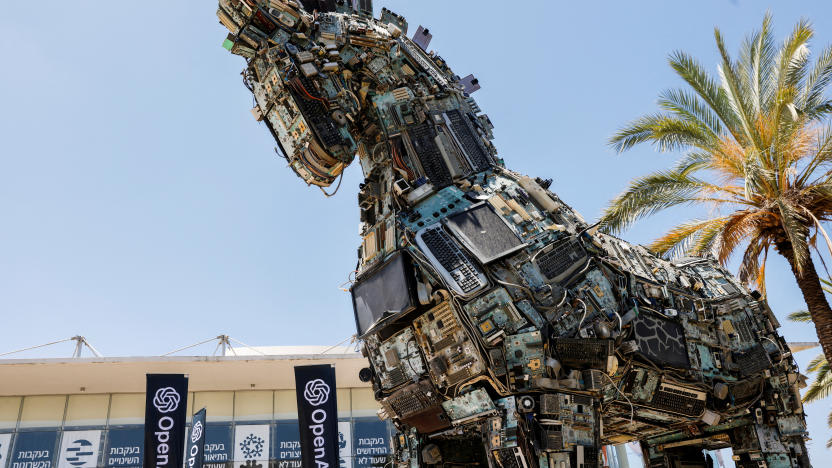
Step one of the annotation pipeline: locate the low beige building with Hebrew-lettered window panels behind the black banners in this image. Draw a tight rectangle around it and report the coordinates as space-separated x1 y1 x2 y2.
0 347 392 468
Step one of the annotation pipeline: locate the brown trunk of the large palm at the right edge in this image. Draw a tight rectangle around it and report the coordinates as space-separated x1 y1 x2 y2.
775 241 832 362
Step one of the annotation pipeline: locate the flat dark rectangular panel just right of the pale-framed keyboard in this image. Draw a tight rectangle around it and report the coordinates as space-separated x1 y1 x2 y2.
443 203 526 264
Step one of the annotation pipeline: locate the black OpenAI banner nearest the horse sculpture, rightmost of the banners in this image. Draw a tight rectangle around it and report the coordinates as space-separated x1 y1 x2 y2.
295 364 339 468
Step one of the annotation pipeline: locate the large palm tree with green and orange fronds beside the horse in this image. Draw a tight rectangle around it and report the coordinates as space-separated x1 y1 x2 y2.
601 14 832 361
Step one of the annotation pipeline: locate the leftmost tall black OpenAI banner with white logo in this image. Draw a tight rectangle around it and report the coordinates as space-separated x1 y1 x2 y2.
143 374 188 468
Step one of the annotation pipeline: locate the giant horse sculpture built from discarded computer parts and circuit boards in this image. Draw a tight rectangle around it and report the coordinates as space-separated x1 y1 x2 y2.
217 0 810 468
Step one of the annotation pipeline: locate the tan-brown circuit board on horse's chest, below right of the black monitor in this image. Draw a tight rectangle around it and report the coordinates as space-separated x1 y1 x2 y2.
413 301 485 387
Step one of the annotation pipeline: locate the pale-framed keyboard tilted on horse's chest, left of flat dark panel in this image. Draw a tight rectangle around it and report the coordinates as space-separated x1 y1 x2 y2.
416 224 488 296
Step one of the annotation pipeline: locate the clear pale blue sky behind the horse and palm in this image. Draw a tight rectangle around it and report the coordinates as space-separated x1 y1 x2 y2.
0 0 832 460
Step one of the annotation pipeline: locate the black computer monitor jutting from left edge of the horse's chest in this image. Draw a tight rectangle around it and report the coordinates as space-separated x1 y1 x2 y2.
350 251 416 336
